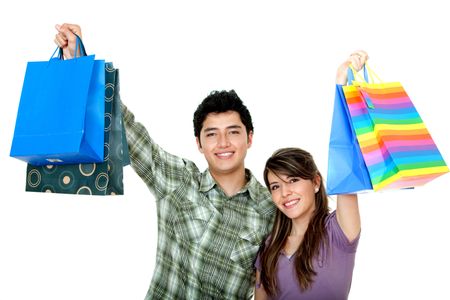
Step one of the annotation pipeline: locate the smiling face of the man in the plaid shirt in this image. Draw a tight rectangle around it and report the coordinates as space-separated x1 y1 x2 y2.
197 111 253 175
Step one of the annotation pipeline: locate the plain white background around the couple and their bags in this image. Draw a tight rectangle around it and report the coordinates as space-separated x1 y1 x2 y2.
0 0 450 300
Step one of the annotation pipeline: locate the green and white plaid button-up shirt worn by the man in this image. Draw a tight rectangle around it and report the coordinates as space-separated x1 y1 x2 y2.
123 106 275 299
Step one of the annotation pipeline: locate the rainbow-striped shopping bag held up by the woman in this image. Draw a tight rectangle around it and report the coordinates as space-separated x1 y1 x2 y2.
343 65 449 191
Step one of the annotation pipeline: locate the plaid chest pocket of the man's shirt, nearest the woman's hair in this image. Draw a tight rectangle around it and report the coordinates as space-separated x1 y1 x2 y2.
230 227 265 270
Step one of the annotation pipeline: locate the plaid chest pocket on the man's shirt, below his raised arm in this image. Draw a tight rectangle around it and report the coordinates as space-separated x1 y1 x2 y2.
170 201 212 244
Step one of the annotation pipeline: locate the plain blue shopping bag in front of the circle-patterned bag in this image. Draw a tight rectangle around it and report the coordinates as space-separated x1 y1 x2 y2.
10 38 105 165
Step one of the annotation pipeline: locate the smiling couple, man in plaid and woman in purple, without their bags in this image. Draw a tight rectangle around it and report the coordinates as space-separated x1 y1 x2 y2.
55 24 367 299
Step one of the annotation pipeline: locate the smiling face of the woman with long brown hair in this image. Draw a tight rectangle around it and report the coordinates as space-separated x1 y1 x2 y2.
267 171 320 219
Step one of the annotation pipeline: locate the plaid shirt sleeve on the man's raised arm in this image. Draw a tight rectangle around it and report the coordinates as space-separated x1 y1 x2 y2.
122 104 186 200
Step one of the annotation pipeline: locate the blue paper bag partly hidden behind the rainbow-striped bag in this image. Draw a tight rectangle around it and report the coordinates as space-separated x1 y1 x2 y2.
326 69 372 195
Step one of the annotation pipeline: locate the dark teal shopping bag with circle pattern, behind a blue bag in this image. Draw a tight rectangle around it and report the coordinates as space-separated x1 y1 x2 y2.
26 63 129 195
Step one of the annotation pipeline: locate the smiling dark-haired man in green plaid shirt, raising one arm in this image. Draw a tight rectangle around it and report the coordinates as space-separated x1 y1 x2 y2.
55 24 274 299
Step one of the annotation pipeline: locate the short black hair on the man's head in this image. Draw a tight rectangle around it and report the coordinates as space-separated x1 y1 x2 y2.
194 90 253 139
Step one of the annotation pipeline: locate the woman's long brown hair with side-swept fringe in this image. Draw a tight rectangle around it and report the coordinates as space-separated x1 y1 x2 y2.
261 148 329 296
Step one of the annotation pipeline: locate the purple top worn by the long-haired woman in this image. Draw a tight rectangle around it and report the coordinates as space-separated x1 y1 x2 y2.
255 211 359 300
